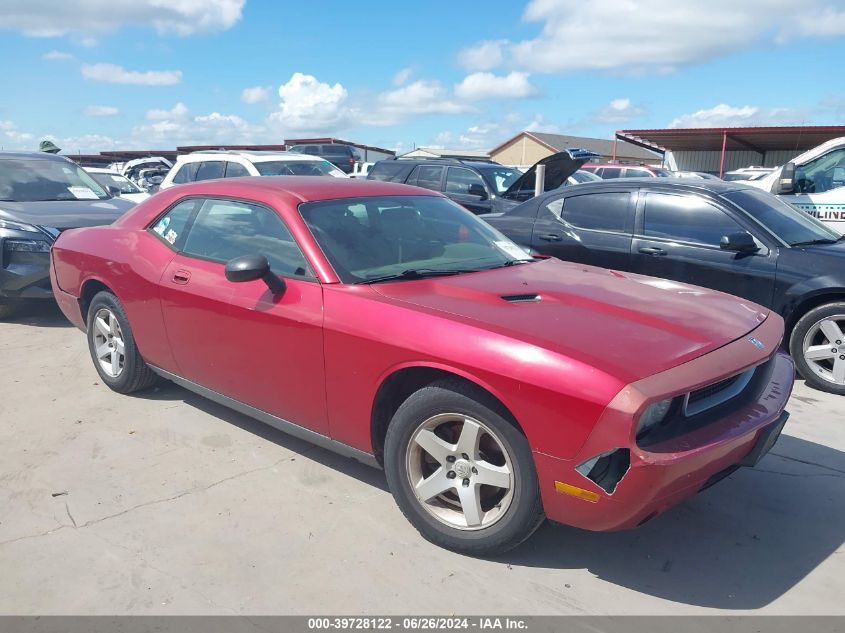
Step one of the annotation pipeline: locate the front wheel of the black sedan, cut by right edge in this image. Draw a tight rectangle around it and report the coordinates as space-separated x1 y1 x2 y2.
789 302 845 395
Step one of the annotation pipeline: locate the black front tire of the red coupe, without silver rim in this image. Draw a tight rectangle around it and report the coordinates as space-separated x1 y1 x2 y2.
384 380 544 556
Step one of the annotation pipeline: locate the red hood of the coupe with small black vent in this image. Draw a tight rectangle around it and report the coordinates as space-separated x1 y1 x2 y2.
372 259 769 383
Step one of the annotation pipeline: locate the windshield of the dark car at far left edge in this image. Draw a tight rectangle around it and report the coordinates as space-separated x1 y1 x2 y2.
0 158 111 202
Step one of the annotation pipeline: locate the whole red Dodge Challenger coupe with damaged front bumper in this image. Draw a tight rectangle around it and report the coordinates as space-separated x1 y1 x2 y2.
51 177 793 554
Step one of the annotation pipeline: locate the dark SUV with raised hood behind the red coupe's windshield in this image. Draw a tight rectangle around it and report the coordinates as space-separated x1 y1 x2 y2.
367 148 597 214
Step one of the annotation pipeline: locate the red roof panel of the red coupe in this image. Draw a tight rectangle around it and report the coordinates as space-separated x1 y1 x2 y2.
157 176 442 202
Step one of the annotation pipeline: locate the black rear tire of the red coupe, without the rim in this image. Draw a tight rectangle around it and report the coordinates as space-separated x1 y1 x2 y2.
87 291 158 393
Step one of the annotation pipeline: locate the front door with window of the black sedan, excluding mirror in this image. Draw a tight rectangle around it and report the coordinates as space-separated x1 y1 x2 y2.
631 191 777 306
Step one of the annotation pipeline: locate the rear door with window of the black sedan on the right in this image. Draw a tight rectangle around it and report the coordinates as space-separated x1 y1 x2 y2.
531 188 635 270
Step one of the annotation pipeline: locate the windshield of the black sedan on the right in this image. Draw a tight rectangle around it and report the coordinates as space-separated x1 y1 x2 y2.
724 189 841 246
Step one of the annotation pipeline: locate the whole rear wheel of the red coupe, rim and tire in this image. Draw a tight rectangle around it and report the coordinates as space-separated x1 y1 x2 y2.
88 291 158 393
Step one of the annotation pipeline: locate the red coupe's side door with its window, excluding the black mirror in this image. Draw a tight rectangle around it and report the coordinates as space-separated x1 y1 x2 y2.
154 198 328 434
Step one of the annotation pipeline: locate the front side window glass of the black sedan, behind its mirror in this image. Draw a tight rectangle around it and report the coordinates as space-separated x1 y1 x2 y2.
643 193 744 247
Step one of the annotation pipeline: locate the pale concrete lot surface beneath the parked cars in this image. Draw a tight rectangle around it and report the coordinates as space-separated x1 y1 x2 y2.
0 306 845 615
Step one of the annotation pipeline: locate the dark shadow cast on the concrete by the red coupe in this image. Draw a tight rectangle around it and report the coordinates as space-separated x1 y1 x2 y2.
139 382 845 610
